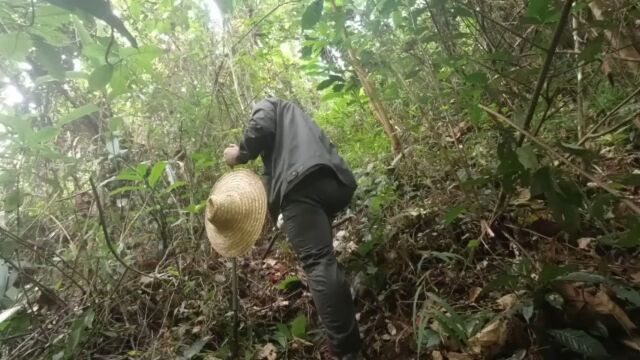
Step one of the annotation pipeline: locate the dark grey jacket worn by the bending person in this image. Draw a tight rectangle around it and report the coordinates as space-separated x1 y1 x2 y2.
237 98 356 217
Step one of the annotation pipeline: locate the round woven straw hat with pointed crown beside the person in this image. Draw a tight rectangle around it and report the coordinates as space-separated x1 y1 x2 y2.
205 169 267 257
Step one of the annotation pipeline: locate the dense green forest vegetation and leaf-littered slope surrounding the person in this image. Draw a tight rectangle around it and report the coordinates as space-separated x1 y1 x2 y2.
0 0 640 360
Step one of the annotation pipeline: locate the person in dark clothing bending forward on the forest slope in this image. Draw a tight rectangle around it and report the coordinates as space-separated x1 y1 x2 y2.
224 98 362 359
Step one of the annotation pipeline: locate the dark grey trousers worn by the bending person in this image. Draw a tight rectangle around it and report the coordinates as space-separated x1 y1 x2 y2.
282 168 361 356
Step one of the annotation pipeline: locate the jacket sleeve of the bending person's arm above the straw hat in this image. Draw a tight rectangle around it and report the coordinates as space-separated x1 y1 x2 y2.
236 100 276 164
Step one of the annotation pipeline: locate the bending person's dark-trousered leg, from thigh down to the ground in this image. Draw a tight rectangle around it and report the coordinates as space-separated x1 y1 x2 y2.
283 187 361 356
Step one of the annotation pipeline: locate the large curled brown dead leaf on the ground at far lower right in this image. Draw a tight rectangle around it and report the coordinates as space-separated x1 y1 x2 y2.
557 283 636 333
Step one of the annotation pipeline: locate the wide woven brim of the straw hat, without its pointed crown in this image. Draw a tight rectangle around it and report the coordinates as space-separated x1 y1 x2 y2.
205 169 267 257
